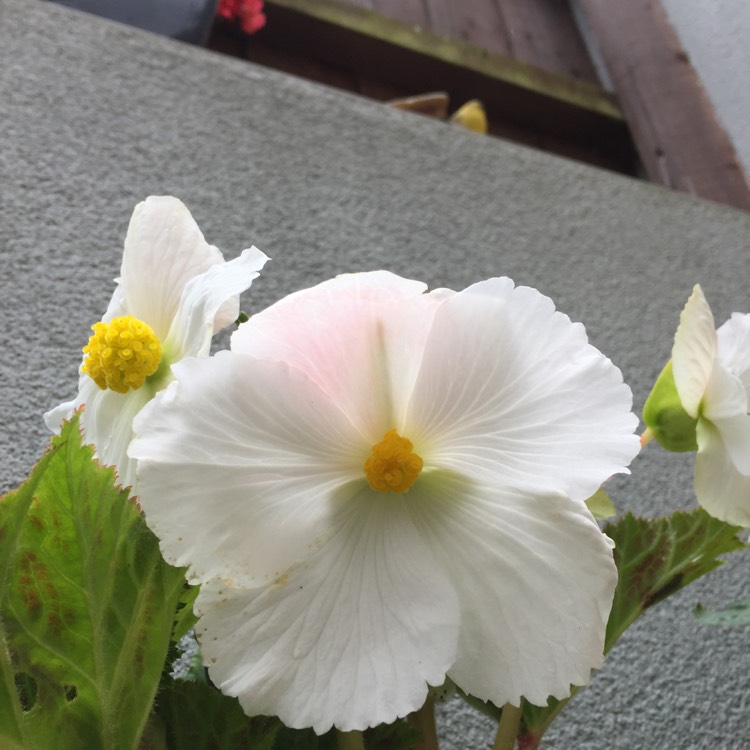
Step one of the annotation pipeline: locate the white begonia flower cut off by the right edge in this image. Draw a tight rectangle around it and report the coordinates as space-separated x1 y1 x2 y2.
672 284 750 527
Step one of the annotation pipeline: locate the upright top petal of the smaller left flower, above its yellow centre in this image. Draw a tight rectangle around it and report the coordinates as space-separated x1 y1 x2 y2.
120 196 224 341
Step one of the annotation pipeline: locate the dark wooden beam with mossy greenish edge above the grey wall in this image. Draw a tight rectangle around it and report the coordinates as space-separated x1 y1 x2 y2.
262 0 624 130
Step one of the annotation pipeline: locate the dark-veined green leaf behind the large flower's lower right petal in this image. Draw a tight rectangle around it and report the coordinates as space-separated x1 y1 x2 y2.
521 509 747 750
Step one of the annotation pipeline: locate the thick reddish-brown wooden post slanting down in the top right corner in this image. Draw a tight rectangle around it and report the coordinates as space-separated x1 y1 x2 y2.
580 0 750 210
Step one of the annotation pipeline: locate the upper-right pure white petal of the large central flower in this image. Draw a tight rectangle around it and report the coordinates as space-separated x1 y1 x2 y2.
402 279 639 500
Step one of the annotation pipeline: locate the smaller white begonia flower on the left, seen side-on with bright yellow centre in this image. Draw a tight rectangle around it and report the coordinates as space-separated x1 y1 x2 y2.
44 196 268 486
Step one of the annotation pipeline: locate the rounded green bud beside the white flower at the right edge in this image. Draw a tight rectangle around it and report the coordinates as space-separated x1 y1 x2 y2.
643 359 698 453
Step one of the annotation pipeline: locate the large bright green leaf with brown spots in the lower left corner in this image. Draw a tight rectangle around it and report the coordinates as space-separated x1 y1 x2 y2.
0 416 184 750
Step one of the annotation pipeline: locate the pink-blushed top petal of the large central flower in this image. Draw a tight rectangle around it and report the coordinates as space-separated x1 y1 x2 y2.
232 271 451 442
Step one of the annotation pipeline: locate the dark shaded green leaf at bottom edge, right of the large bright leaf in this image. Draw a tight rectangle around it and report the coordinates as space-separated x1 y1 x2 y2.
156 679 283 750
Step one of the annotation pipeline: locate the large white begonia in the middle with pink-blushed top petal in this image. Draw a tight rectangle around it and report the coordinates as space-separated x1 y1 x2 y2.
131 272 638 732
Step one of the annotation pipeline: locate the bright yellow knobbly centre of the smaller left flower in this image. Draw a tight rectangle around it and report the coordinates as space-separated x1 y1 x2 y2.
83 315 161 393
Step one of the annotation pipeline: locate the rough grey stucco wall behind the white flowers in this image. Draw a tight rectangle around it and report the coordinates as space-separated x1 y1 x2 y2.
0 0 750 750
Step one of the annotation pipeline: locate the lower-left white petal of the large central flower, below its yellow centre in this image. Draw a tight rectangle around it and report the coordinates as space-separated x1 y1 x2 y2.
196 488 463 734
